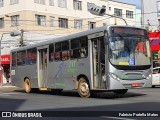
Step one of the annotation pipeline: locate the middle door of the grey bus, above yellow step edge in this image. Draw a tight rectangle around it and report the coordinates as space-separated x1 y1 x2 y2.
37 48 48 90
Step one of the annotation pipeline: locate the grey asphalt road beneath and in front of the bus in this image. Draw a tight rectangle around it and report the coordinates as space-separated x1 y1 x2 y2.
0 88 160 120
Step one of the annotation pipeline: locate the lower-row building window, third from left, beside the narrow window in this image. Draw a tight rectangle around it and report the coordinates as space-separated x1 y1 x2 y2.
35 15 46 26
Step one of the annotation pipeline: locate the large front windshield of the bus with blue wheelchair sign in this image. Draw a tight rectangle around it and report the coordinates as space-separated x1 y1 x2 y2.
109 36 151 66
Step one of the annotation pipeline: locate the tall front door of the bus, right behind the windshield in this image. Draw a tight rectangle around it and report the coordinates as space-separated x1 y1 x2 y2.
91 37 105 89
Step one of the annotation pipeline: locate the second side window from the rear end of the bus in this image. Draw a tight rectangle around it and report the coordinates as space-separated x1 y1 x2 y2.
17 51 26 65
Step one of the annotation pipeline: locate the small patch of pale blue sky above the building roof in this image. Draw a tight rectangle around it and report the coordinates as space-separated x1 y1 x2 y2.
114 0 141 9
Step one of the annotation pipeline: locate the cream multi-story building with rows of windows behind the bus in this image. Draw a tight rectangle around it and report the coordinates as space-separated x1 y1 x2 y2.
0 0 135 46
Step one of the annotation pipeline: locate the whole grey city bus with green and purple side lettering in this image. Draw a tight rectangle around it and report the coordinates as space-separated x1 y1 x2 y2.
11 26 152 97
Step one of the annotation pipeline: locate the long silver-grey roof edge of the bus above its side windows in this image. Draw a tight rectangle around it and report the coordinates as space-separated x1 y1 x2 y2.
11 25 144 52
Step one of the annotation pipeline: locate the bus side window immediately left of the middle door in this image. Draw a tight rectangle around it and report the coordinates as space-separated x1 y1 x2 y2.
26 48 37 65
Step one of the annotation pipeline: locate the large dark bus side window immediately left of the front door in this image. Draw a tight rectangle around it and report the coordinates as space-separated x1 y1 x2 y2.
70 37 88 59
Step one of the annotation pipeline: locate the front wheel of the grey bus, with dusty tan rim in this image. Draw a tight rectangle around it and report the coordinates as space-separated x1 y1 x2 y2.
78 77 91 98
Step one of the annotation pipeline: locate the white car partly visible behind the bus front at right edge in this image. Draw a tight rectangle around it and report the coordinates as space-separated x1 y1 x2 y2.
152 67 160 87
